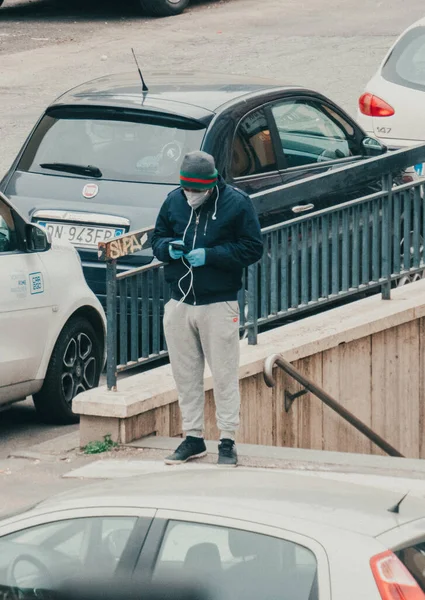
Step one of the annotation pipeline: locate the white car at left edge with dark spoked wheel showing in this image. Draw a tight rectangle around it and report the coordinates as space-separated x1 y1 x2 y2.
0 194 106 423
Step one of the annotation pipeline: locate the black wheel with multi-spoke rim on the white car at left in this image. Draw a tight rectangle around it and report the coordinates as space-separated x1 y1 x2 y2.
34 317 102 425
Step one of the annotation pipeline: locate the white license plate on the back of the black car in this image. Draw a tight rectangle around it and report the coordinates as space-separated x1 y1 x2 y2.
38 221 124 248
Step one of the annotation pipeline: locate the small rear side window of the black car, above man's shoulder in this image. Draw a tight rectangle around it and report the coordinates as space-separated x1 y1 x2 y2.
231 109 277 177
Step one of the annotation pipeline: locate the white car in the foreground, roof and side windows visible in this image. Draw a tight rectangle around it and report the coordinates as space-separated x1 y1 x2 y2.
0 465 425 600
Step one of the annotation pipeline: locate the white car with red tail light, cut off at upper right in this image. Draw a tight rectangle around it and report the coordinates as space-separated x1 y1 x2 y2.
357 18 425 175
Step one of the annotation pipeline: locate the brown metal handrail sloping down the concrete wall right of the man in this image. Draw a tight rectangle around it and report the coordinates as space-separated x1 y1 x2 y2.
263 354 405 458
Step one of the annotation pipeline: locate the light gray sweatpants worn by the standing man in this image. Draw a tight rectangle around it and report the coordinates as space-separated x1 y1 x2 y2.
164 300 240 439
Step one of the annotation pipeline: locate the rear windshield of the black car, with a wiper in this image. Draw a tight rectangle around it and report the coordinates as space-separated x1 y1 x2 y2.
18 113 205 184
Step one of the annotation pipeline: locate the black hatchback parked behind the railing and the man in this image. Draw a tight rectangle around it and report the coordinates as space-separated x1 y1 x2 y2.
0 73 386 299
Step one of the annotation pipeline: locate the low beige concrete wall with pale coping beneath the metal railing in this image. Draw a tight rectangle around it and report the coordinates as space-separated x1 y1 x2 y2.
74 281 425 458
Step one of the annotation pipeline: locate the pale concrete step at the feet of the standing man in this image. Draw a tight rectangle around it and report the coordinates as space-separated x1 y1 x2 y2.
63 437 425 498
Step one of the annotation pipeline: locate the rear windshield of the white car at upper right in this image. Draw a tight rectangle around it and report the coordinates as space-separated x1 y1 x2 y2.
382 27 425 91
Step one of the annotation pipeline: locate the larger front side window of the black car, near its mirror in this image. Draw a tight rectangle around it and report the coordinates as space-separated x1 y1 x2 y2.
272 99 355 168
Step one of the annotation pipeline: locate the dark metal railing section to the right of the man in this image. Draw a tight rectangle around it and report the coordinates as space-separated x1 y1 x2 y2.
247 177 425 344
